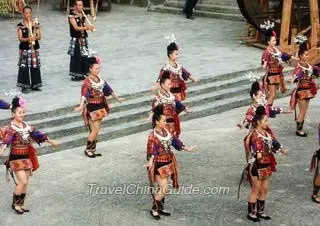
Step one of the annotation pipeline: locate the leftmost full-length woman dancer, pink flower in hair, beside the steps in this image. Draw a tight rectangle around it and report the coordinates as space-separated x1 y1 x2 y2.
0 97 58 214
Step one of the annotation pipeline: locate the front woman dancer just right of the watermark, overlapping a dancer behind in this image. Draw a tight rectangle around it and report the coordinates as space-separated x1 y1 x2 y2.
240 106 288 222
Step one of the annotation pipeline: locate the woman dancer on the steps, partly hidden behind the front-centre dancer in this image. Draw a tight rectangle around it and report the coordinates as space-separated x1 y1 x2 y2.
147 71 191 137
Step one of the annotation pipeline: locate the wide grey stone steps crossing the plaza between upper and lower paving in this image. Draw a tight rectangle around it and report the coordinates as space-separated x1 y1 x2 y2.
0 69 296 155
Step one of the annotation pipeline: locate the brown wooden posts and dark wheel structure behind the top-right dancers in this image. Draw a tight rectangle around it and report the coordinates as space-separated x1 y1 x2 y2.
237 0 320 64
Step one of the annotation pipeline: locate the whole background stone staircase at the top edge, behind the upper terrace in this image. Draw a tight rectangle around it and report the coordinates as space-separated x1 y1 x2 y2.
148 0 244 21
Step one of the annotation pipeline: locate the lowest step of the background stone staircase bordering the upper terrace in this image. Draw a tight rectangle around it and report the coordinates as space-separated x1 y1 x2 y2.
148 5 245 21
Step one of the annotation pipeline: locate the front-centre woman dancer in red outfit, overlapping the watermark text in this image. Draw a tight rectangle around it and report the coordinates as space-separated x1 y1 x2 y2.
145 105 196 220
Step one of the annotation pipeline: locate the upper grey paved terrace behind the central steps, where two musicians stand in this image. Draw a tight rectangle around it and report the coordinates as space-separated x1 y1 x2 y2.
0 4 261 117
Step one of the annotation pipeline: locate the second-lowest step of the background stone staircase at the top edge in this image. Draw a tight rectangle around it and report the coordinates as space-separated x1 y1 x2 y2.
163 1 241 15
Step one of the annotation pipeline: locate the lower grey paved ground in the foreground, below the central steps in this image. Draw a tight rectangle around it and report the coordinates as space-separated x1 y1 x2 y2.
0 94 320 226
